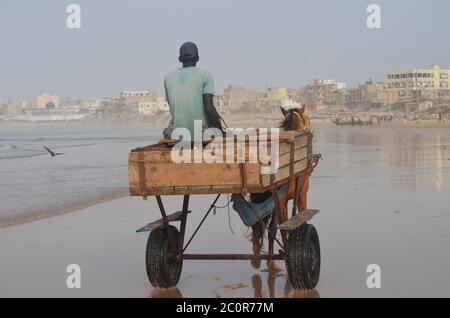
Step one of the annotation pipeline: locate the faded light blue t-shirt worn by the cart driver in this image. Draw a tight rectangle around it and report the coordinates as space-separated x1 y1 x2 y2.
164 67 214 138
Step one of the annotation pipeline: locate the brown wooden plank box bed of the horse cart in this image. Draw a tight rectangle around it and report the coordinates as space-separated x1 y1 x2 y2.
129 131 312 197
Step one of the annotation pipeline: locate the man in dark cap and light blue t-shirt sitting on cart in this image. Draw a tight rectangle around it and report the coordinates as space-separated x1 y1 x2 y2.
163 42 223 139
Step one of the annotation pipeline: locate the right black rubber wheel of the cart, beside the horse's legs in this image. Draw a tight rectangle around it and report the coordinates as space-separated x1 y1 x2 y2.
286 224 320 289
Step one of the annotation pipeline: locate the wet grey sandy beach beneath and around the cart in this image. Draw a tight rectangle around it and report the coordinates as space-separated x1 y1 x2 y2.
0 127 450 297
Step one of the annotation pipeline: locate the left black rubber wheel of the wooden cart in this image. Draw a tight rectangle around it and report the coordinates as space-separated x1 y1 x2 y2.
145 226 183 288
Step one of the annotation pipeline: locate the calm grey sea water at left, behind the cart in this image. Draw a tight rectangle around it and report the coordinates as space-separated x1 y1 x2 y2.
0 127 160 226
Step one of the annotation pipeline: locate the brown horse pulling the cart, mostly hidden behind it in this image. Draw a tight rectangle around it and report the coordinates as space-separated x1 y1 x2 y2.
251 106 318 270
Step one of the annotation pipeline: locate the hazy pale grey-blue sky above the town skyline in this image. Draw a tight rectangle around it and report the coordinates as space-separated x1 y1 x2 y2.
0 0 450 100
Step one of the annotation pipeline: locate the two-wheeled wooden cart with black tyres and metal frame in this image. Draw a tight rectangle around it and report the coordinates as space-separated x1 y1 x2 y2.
129 131 320 289
